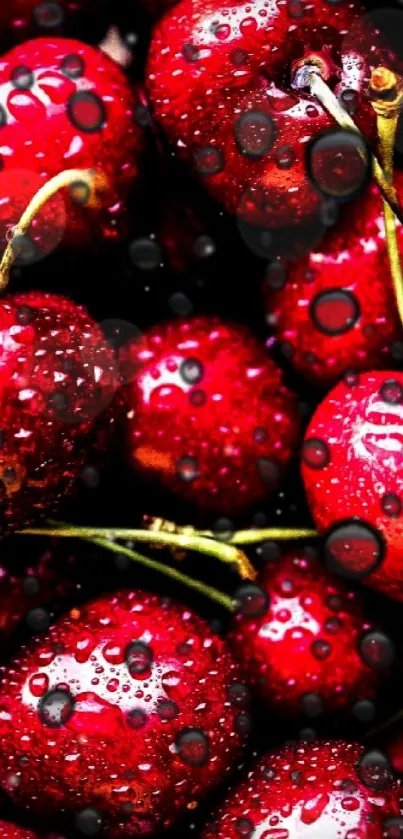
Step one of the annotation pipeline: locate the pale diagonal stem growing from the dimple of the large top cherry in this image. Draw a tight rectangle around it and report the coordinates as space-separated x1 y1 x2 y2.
306 67 403 224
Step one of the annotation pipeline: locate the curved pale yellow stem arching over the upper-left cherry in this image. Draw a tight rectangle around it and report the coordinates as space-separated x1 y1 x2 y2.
0 169 96 292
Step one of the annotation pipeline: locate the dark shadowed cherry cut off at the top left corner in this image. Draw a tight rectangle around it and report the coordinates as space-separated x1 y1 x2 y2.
0 0 109 48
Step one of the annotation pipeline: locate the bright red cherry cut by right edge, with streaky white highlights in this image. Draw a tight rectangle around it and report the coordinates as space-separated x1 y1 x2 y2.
302 371 403 600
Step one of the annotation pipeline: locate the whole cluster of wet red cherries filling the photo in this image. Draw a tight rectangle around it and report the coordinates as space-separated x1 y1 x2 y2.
0 0 403 839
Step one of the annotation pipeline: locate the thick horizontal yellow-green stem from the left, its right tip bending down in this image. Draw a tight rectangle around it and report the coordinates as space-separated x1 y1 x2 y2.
17 522 257 580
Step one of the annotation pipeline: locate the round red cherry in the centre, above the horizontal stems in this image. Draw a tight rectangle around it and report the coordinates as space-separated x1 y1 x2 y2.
121 317 299 513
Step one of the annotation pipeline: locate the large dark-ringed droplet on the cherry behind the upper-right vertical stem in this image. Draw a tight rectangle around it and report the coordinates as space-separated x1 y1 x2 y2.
310 289 360 335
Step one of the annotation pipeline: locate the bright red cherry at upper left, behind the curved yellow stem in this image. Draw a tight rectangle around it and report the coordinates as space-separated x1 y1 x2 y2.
0 38 141 261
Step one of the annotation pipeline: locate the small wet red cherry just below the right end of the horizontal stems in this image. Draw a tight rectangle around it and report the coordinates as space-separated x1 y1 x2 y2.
230 552 382 717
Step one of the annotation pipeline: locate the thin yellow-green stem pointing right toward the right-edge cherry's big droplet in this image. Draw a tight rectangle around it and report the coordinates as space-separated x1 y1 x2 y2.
144 516 319 545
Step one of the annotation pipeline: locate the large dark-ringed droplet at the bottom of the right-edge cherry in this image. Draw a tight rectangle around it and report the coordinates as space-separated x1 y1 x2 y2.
325 519 384 579
